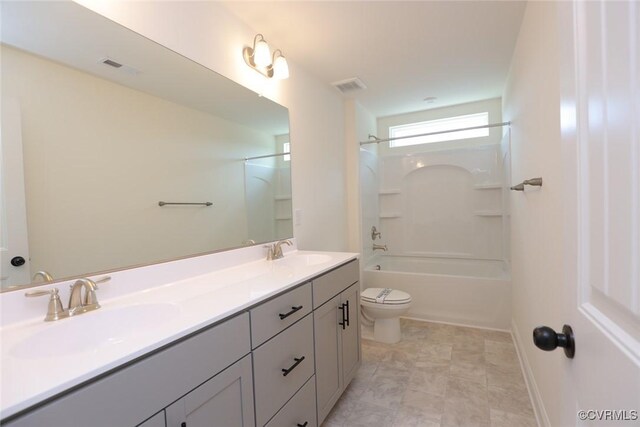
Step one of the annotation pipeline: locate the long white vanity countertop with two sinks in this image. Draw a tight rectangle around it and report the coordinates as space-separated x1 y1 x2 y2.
0 251 358 419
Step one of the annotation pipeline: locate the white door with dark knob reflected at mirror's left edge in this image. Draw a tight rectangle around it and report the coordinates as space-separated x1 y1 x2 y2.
0 98 31 288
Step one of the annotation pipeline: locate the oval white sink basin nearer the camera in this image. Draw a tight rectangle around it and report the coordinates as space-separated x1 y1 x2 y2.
10 303 181 359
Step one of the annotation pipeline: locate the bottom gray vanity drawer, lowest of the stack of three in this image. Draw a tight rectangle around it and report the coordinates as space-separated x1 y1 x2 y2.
265 375 317 427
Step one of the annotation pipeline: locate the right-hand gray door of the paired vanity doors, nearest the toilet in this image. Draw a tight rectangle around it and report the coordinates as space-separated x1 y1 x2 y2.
340 283 360 388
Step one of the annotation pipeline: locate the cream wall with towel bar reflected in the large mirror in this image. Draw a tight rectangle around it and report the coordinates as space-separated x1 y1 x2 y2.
1 45 278 278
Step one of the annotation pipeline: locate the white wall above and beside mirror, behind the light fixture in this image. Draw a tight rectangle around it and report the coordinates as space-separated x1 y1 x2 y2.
77 0 347 250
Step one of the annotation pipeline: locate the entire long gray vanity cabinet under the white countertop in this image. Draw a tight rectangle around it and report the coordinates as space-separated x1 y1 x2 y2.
3 260 360 427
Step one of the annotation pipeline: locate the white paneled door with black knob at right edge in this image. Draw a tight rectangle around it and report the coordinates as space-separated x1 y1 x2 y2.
561 1 640 426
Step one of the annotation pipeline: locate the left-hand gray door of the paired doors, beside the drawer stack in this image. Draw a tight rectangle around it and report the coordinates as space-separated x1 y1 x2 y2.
313 295 342 424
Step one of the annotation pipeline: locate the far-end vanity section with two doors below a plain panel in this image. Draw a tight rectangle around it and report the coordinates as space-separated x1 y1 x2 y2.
313 261 361 424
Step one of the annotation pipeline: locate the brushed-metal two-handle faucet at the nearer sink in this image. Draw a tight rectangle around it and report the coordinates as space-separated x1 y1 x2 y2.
24 276 111 322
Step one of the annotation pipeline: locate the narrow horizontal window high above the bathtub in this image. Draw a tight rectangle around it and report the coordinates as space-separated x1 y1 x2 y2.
389 112 489 148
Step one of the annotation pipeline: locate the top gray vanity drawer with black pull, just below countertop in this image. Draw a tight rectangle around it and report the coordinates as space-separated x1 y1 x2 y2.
250 282 311 348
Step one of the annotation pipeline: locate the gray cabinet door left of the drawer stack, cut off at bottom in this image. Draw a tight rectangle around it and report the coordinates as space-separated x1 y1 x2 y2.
166 356 255 427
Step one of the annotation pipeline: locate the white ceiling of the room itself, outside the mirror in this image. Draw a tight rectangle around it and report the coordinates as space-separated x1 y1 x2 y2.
223 0 525 117
